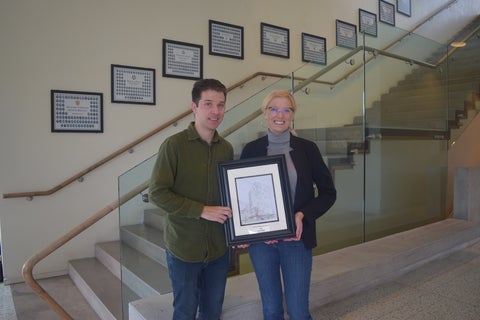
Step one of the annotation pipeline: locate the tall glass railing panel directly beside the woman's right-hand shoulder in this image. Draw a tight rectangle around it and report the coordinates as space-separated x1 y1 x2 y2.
295 61 364 255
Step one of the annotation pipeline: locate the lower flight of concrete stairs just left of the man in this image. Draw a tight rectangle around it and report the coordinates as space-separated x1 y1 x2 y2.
69 209 171 320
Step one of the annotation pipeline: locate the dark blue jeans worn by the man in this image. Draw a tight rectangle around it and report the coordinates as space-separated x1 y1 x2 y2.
167 250 228 320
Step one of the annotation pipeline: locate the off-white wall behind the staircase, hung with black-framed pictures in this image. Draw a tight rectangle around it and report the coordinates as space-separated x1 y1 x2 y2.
0 0 480 283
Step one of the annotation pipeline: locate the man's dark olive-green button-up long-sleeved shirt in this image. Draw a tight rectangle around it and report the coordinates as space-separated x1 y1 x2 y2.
149 122 233 262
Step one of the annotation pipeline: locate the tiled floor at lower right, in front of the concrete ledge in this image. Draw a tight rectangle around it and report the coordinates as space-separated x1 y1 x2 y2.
312 242 480 320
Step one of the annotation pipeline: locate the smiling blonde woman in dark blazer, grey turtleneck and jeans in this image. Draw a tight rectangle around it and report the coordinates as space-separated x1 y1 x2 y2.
241 90 336 320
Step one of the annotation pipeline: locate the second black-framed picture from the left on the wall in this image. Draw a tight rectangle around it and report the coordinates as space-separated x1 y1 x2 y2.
111 64 155 105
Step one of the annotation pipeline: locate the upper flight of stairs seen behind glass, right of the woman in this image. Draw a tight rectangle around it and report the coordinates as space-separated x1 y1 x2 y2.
296 17 480 170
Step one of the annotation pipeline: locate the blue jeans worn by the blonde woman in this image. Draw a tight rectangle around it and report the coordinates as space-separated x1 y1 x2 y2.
248 241 312 320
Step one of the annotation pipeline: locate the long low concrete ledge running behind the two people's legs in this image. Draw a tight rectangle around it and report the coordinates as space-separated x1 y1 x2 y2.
129 219 480 320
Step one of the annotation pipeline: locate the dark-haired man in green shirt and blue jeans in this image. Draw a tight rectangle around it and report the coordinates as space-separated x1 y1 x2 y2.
149 79 233 320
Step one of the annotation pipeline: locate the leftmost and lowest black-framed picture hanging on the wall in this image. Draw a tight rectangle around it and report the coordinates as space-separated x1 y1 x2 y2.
50 90 103 132
